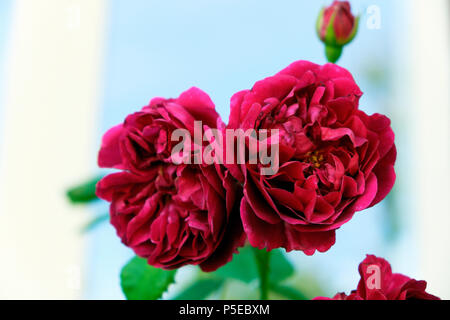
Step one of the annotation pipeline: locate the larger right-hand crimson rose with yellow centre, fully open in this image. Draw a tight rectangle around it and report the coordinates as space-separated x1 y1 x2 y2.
228 61 396 255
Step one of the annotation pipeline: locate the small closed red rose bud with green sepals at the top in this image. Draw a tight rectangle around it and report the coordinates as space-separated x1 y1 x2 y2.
317 1 359 63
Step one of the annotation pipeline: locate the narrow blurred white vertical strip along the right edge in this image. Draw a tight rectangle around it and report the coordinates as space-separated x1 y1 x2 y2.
407 0 450 299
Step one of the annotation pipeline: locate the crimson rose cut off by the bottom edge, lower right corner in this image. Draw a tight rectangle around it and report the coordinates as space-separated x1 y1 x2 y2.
314 255 440 300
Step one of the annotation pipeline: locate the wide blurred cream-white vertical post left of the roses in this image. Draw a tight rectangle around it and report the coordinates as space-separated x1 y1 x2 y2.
0 0 106 299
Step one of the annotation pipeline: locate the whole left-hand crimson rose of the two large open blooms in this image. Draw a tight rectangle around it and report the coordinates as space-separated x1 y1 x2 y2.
97 88 245 271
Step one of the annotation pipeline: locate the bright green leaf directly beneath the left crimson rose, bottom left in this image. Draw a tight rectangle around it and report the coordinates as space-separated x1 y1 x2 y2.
120 257 176 300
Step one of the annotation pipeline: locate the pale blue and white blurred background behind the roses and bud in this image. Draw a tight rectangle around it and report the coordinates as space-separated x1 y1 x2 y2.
0 0 450 299
